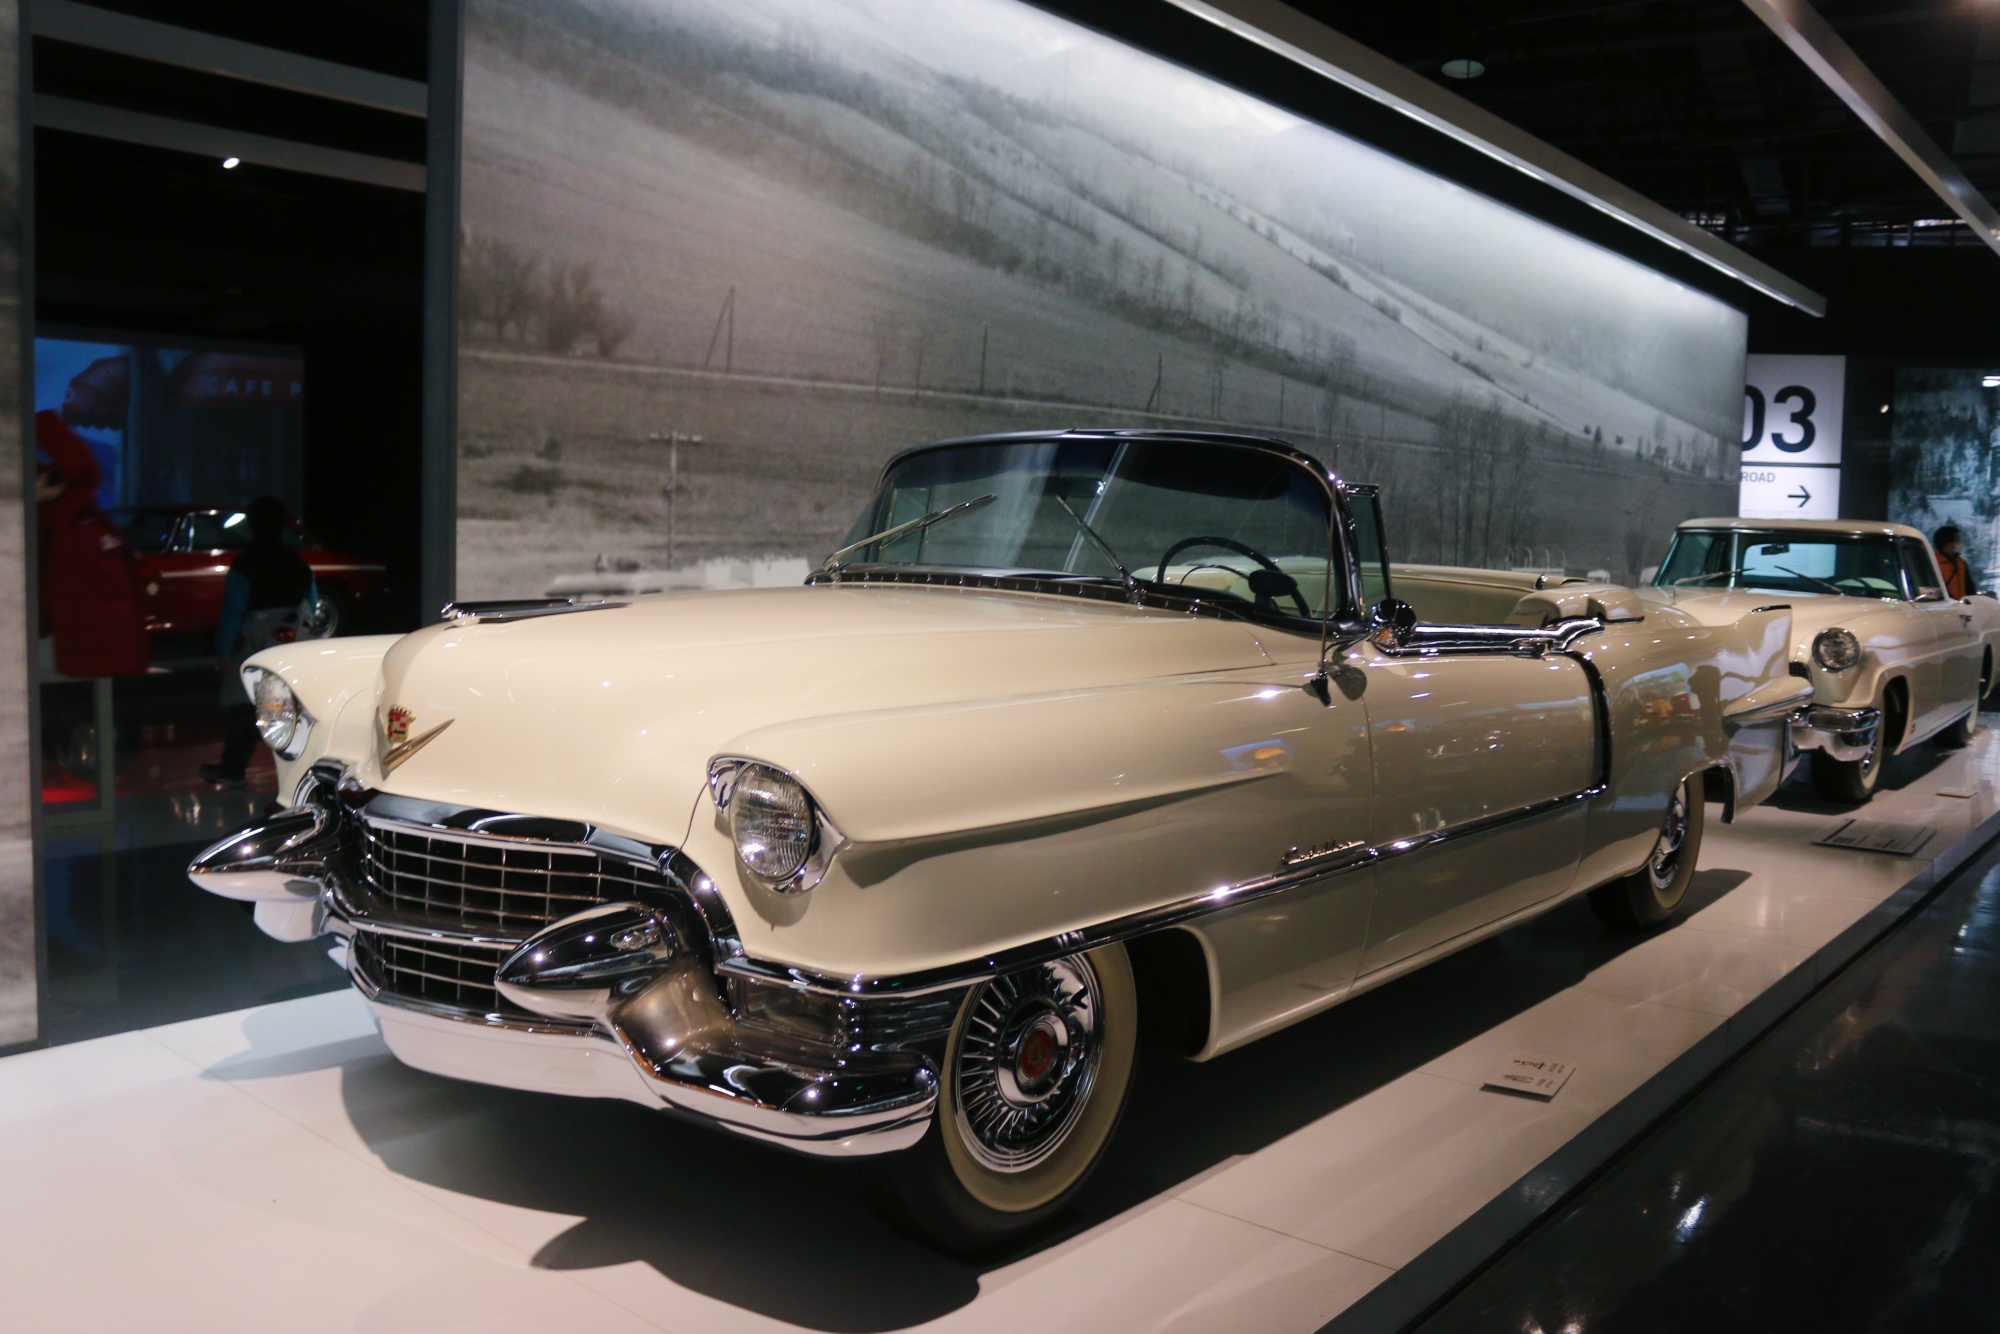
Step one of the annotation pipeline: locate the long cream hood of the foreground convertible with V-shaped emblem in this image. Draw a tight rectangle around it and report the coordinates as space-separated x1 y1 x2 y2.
362 586 1268 842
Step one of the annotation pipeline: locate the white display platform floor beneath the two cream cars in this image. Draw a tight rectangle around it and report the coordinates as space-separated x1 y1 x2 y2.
0 732 2000 1334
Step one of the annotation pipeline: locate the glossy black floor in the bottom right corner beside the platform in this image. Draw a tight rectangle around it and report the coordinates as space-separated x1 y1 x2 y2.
1418 836 2000 1334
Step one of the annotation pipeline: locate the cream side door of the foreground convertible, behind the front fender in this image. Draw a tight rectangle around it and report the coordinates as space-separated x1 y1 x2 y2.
1354 626 1598 976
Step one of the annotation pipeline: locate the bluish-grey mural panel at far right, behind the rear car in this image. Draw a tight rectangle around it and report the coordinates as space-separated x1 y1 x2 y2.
1888 368 2000 588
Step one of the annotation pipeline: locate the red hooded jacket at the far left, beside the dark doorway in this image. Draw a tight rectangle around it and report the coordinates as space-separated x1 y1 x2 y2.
34 412 152 676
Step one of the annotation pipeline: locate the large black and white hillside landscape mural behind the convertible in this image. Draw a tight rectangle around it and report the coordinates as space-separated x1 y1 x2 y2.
458 0 1744 598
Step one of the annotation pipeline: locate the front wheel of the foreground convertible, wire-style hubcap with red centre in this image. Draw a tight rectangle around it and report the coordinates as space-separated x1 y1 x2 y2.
868 946 1138 1254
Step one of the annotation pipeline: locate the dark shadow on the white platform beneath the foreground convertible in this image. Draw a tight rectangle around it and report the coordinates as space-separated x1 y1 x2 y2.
304 870 1748 1332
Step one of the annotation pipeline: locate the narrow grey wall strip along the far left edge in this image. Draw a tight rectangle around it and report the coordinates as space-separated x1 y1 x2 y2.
0 0 40 1050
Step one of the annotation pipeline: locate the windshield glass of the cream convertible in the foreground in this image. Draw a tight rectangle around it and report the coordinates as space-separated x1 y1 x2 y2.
836 438 1340 618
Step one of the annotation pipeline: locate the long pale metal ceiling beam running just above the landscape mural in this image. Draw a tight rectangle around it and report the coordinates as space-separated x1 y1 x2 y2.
1168 0 1826 316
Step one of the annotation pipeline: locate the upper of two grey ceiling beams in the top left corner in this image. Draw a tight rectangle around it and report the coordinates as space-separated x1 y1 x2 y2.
30 0 428 116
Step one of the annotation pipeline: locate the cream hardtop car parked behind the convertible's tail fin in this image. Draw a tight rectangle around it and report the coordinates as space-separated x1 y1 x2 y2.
1644 518 2000 802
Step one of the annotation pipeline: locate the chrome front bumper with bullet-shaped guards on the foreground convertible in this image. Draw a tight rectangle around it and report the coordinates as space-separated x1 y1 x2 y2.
188 784 936 1156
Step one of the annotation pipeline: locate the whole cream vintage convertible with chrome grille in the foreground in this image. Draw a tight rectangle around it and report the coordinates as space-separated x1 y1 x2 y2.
190 432 1800 1250
